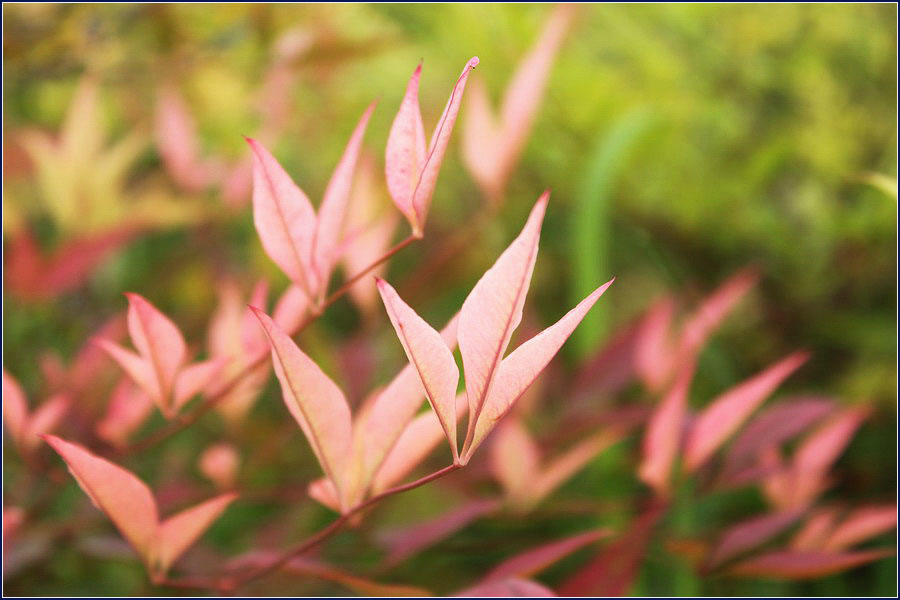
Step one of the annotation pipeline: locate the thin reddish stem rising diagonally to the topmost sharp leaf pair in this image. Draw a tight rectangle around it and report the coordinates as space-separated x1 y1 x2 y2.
117 235 419 455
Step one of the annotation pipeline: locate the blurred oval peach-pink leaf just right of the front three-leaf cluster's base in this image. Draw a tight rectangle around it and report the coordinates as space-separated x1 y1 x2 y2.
490 417 541 503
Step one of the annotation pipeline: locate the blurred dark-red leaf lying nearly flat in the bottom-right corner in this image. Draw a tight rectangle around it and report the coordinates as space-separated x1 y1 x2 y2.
729 549 894 580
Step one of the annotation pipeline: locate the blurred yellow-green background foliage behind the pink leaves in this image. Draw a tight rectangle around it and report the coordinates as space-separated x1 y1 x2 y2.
3 4 897 595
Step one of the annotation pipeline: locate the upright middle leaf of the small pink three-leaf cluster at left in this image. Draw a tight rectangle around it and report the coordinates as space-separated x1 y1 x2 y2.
125 293 187 412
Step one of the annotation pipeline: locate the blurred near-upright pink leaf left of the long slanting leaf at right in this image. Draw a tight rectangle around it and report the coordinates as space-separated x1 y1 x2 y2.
638 363 694 496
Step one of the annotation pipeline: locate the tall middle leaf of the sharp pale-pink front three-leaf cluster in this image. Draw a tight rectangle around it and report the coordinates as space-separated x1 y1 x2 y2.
458 192 550 452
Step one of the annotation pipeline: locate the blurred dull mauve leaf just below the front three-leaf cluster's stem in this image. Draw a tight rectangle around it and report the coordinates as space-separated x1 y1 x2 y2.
379 500 500 567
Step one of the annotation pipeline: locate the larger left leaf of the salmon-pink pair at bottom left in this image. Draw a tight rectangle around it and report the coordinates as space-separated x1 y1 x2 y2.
44 435 158 567
